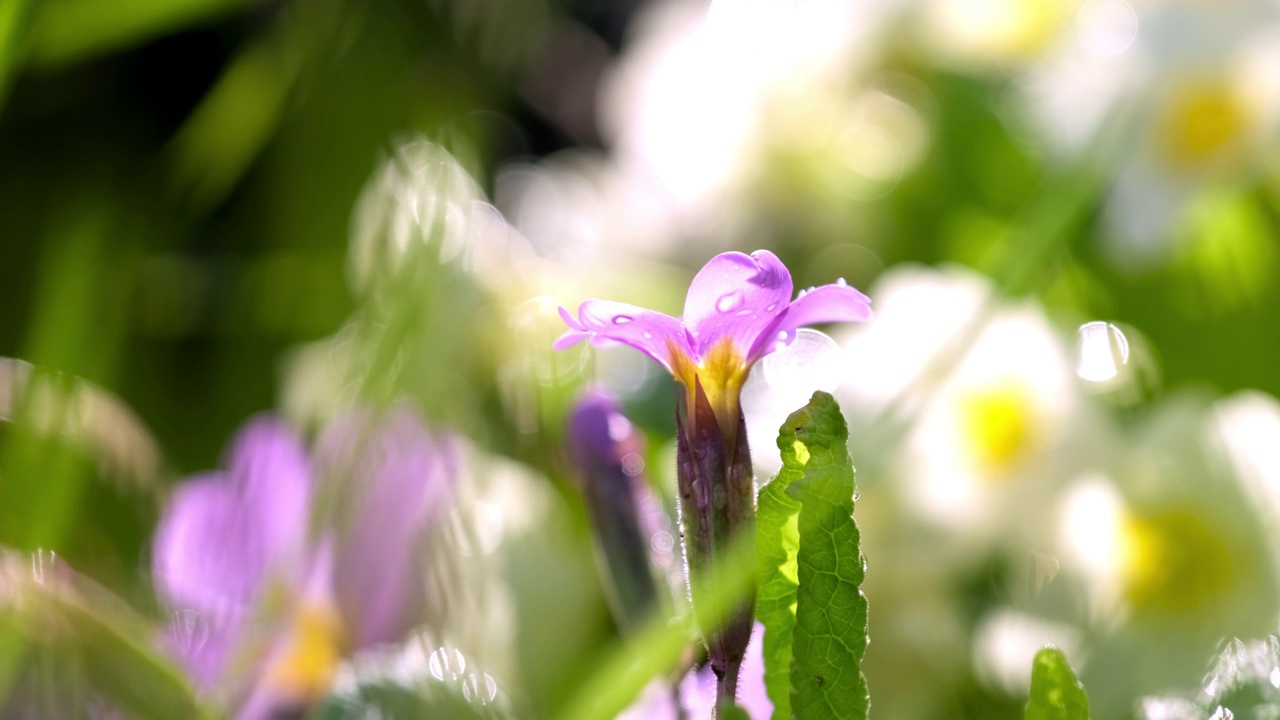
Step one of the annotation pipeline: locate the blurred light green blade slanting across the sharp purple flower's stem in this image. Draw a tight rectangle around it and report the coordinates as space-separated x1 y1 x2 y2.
554 536 755 720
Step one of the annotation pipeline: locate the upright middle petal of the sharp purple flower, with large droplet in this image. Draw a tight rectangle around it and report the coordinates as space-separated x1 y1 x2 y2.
684 250 791 357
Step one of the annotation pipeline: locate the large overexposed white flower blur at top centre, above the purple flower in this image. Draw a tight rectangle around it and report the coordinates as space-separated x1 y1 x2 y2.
600 0 927 238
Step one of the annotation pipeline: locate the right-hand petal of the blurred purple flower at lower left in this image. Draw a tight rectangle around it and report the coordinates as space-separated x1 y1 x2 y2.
321 409 454 648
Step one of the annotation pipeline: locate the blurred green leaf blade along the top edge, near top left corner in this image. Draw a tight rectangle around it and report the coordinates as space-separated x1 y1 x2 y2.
27 0 256 65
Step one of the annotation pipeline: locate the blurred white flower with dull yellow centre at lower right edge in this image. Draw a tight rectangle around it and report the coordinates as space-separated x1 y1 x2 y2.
1059 396 1280 716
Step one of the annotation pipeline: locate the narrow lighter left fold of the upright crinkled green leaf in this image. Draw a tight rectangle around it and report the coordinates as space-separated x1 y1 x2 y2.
755 404 809 717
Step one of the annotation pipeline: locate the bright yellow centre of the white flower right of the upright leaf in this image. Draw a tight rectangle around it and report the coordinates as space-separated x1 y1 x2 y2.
960 380 1036 479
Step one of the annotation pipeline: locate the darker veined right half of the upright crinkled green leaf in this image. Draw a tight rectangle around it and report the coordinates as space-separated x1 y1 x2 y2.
778 391 870 720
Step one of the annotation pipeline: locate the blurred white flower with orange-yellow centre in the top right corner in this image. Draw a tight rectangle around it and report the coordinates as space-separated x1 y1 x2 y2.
1021 0 1280 272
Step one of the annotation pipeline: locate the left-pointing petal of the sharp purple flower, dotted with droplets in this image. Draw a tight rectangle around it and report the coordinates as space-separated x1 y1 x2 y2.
556 300 690 372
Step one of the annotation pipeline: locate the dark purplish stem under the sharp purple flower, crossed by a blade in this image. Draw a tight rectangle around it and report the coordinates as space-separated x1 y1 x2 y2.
676 382 755 715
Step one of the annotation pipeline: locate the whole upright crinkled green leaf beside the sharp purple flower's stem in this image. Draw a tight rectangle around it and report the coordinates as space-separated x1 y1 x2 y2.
756 392 870 720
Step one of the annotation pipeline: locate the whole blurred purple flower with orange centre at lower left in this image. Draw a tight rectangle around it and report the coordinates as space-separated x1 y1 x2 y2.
152 410 454 717
